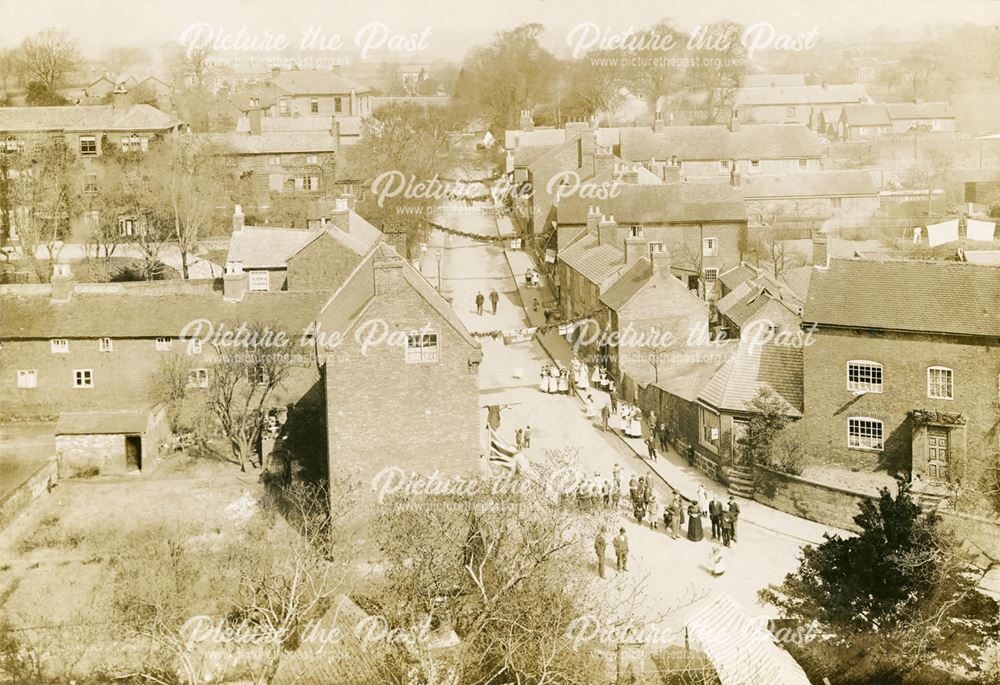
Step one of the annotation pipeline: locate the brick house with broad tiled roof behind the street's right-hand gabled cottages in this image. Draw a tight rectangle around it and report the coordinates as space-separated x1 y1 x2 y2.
556 183 747 299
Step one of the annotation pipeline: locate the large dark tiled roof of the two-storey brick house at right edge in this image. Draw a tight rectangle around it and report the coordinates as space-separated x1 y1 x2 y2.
802 259 1000 337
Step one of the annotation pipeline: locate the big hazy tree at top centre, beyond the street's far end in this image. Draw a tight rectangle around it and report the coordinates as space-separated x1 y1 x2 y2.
455 24 559 131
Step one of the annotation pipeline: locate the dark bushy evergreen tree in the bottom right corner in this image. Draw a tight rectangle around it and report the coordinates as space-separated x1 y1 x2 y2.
760 487 1000 684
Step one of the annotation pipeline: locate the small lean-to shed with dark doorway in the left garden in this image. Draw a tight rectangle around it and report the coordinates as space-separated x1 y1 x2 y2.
55 407 169 477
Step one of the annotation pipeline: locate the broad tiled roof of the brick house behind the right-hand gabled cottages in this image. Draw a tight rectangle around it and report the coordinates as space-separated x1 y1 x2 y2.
556 183 747 224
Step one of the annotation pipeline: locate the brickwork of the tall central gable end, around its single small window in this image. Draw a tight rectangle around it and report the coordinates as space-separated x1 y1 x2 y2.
325 268 481 496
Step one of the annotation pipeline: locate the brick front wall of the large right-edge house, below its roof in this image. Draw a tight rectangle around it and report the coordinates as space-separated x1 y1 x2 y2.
803 328 1000 475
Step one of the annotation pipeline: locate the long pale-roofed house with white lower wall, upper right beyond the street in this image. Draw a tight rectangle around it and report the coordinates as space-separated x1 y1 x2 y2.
618 118 822 180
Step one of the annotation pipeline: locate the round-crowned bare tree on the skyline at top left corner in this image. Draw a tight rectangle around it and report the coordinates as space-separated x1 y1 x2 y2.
17 28 83 104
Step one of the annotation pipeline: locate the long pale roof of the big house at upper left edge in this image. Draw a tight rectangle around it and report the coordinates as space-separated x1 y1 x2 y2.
0 105 181 133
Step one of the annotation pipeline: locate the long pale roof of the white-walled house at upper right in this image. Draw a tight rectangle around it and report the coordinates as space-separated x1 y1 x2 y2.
619 124 822 162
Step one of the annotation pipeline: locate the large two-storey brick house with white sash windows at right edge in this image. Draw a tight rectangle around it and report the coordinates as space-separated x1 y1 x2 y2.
803 259 1000 492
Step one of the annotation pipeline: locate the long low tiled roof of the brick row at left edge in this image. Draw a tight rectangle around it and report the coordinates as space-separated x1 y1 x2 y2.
0 284 329 339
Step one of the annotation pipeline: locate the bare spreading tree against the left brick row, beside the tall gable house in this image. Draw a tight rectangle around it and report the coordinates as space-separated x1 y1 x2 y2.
209 323 293 471
